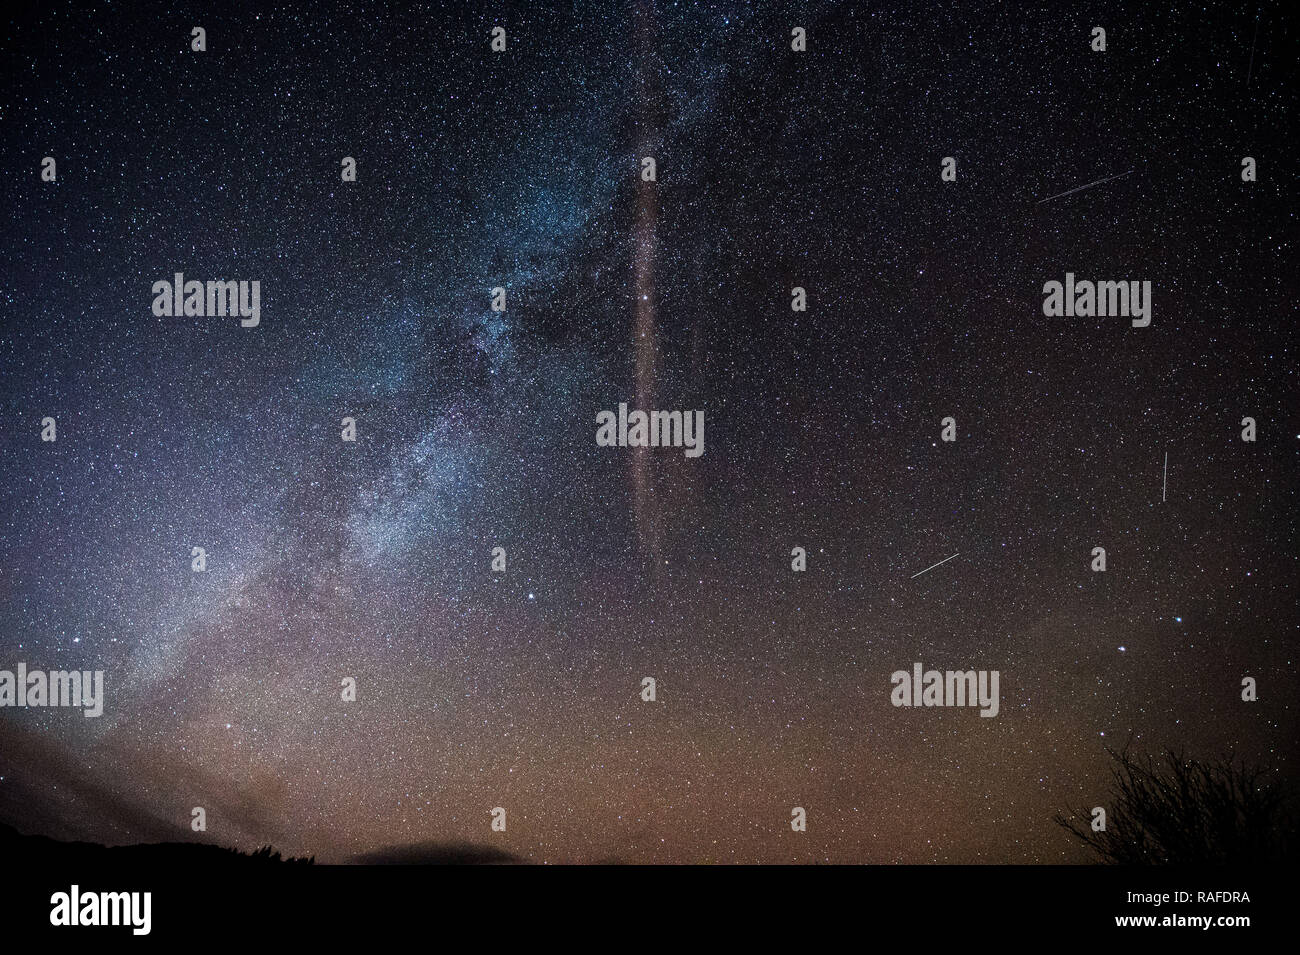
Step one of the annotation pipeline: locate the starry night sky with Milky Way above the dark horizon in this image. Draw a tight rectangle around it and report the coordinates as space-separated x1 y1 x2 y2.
0 0 1300 863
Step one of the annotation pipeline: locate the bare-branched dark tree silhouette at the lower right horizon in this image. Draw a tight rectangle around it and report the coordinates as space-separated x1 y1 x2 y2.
1054 746 1296 865
